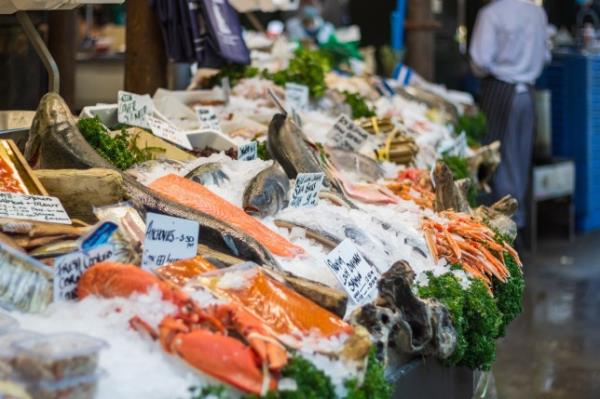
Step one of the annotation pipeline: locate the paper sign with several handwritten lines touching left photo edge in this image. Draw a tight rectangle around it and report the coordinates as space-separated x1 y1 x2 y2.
0 193 71 224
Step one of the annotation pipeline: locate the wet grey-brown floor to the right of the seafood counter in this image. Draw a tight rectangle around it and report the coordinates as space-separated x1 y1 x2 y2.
494 233 600 399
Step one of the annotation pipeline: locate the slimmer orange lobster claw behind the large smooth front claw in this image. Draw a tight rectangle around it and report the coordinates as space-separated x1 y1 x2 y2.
206 304 287 371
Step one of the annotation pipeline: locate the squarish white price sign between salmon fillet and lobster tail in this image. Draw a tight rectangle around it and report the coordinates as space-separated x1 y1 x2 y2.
142 213 199 269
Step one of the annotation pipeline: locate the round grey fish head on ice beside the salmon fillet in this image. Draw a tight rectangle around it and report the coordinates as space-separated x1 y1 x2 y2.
243 163 290 217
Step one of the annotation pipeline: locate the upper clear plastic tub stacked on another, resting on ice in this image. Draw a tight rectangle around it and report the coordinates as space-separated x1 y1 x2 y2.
14 333 108 381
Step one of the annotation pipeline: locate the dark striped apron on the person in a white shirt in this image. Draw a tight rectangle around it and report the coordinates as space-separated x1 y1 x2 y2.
480 77 535 228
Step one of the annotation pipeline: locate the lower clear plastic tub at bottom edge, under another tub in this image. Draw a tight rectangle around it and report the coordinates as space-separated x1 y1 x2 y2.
28 371 105 399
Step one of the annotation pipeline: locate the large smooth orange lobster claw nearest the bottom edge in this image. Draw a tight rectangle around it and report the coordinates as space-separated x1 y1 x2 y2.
168 326 277 395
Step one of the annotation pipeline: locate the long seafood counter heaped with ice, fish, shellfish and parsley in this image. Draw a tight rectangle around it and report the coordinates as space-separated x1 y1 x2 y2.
0 50 523 399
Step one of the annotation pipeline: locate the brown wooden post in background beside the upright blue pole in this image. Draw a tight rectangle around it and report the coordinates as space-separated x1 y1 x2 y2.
406 0 438 80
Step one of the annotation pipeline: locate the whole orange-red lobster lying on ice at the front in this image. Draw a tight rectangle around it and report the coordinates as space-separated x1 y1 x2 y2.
77 262 287 395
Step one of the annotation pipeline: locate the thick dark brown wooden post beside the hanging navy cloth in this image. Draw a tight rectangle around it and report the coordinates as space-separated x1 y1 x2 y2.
125 0 167 95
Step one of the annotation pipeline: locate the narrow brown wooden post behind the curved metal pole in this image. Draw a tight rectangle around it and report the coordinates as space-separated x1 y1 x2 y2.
48 10 79 109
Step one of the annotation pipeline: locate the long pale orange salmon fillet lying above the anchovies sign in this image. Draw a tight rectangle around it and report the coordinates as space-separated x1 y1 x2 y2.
150 174 304 258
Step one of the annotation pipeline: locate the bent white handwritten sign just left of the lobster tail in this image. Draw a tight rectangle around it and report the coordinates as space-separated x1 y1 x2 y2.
54 244 115 302
